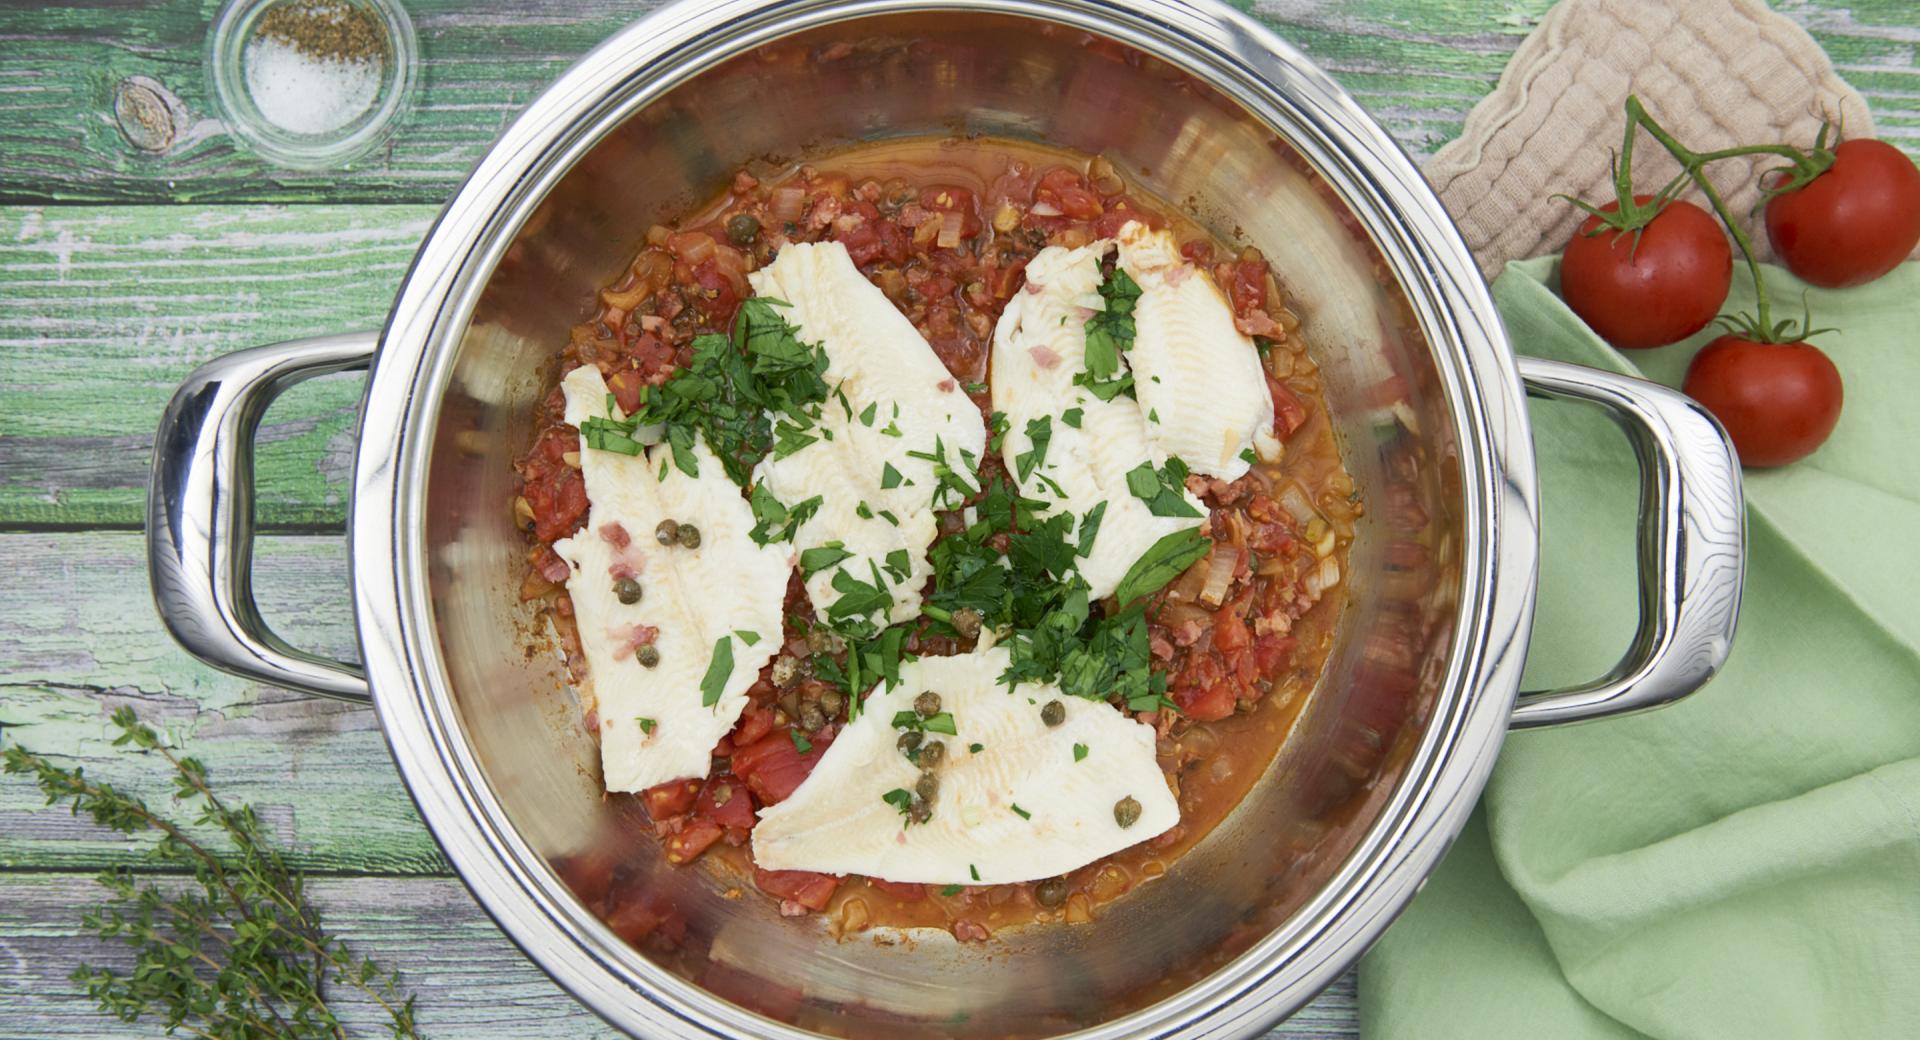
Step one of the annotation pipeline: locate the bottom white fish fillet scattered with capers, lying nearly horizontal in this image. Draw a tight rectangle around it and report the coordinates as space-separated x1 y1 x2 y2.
753 649 1179 885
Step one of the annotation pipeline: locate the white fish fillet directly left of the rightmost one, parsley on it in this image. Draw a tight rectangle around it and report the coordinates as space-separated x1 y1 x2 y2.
993 240 1206 599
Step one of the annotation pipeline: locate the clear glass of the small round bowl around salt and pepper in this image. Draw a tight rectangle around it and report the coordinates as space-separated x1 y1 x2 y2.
207 0 420 169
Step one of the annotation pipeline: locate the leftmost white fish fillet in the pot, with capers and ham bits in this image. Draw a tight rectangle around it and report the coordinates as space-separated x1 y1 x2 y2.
553 365 793 791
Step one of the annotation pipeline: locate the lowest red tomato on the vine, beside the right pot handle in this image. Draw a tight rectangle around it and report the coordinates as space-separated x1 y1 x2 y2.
1680 336 1841 466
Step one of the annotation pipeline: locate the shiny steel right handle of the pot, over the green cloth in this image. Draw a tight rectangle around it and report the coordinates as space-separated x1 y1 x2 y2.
1513 357 1747 729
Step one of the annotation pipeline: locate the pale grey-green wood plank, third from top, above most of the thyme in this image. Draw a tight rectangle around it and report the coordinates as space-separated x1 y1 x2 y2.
0 532 447 874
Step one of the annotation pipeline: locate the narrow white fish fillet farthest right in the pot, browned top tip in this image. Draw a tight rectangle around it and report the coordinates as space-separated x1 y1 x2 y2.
1116 221 1273 480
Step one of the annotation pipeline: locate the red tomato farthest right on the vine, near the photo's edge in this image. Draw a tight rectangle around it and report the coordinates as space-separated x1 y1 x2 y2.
1766 138 1920 288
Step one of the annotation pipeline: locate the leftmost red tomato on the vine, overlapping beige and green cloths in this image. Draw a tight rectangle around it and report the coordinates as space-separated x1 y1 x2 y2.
1561 196 1734 349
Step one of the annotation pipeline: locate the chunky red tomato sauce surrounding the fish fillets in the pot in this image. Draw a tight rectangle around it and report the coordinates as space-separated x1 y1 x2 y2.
513 138 1361 940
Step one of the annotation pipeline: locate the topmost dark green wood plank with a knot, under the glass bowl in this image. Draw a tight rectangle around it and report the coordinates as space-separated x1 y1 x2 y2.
0 0 1920 201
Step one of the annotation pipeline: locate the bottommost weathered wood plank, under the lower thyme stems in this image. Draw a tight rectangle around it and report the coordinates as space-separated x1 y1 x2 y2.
0 873 1359 1040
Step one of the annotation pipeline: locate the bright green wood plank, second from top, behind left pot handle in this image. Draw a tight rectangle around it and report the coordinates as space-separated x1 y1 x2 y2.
0 205 436 528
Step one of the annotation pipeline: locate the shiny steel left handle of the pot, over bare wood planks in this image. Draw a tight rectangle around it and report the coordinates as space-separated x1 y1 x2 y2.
146 332 380 704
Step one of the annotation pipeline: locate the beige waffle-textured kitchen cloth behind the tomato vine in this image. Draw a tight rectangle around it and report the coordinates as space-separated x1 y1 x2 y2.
1427 0 1874 280
